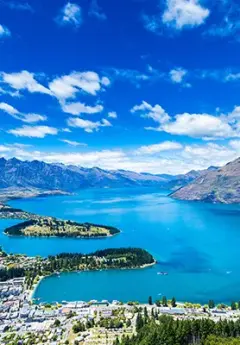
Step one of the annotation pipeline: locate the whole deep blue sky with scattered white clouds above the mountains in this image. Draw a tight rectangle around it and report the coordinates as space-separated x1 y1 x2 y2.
0 0 240 174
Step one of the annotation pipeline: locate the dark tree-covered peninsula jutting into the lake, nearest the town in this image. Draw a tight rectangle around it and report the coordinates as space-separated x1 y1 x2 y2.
0 248 155 288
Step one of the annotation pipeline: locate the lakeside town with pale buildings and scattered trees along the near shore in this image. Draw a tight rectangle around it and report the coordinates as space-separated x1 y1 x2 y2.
0 277 240 345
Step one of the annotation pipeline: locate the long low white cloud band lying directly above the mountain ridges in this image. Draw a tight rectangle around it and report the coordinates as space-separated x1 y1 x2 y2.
0 139 239 174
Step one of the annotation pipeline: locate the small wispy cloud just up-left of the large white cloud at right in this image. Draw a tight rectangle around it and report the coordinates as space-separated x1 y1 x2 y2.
131 101 170 124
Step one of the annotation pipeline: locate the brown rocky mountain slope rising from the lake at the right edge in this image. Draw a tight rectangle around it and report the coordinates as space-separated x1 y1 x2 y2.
171 158 240 204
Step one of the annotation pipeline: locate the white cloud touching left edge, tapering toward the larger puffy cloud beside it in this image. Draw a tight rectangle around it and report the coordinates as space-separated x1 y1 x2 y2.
1 71 52 95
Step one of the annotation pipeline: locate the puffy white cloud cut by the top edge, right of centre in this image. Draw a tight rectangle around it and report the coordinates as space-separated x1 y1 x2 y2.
162 0 210 30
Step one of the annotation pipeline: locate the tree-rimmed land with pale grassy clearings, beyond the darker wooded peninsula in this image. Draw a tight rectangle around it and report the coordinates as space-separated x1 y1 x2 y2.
4 216 120 238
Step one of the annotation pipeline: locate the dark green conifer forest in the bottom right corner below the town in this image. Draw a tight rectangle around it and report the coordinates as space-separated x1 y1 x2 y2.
114 313 240 345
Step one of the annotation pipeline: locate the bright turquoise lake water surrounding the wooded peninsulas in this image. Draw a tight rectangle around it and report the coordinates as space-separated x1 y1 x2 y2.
0 188 240 303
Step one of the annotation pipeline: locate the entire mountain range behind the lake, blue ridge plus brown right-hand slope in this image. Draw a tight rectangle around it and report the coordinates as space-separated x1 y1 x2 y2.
0 158 240 203
